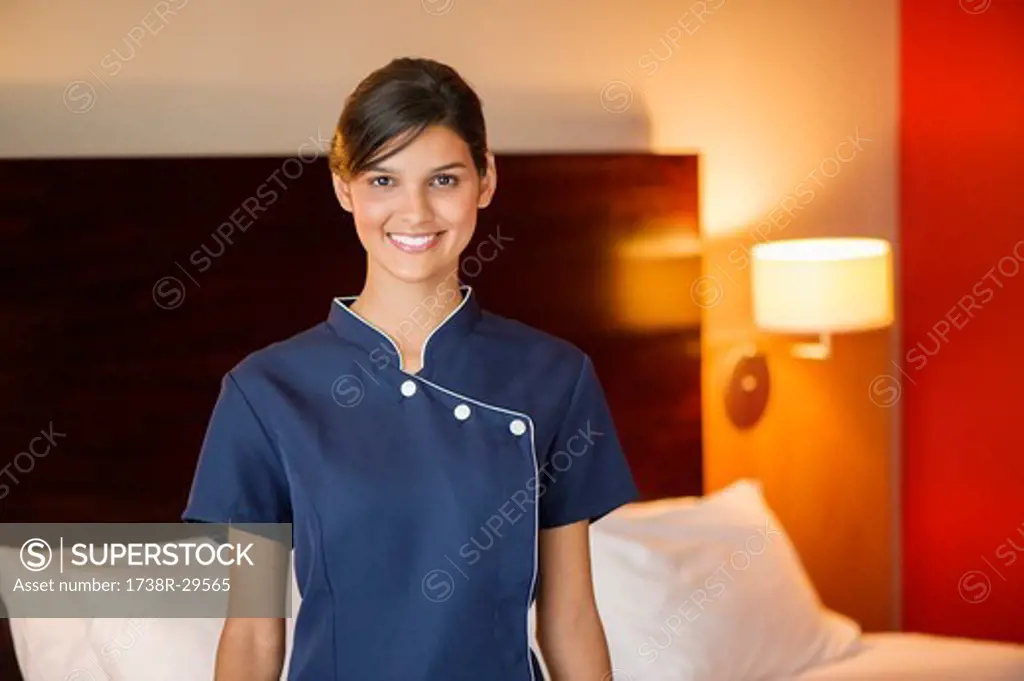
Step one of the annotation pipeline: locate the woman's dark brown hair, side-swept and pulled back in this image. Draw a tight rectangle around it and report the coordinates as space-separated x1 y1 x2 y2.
328 57 487 179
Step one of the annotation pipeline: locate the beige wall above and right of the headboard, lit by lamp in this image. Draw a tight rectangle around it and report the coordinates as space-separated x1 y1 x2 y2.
0 0 898 628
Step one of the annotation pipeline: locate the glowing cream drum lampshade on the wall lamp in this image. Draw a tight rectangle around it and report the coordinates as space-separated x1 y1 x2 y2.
751 238 893 334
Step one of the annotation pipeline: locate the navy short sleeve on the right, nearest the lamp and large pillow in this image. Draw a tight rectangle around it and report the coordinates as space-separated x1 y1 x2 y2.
538 355 639 528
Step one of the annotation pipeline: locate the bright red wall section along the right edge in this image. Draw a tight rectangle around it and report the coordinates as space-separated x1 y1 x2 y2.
900 0 1024 642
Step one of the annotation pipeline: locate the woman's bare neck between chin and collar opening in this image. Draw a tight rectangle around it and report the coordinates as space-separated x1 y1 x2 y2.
351 261 462 358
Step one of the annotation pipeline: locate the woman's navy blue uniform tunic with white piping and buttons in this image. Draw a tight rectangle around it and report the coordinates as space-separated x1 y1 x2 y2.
182 287 637 681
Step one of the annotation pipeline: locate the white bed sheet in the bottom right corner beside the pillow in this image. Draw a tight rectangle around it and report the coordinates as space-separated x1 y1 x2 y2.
793 633 1024 681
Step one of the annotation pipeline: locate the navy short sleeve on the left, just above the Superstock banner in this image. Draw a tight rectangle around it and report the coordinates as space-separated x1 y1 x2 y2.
181 373 292 523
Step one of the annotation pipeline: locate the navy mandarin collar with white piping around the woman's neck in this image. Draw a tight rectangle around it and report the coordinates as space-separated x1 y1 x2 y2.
327 284 481 371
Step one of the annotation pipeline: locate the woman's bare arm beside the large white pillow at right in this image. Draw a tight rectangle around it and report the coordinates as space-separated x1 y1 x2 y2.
536 520 611 681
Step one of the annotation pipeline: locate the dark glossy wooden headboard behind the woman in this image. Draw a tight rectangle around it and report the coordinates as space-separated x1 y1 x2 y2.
0 154 701 679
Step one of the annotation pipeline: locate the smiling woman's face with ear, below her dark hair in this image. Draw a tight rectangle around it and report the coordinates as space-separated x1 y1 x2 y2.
334 126 496 283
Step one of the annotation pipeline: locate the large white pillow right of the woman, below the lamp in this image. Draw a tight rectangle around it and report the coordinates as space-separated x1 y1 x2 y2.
591 480 860 681
